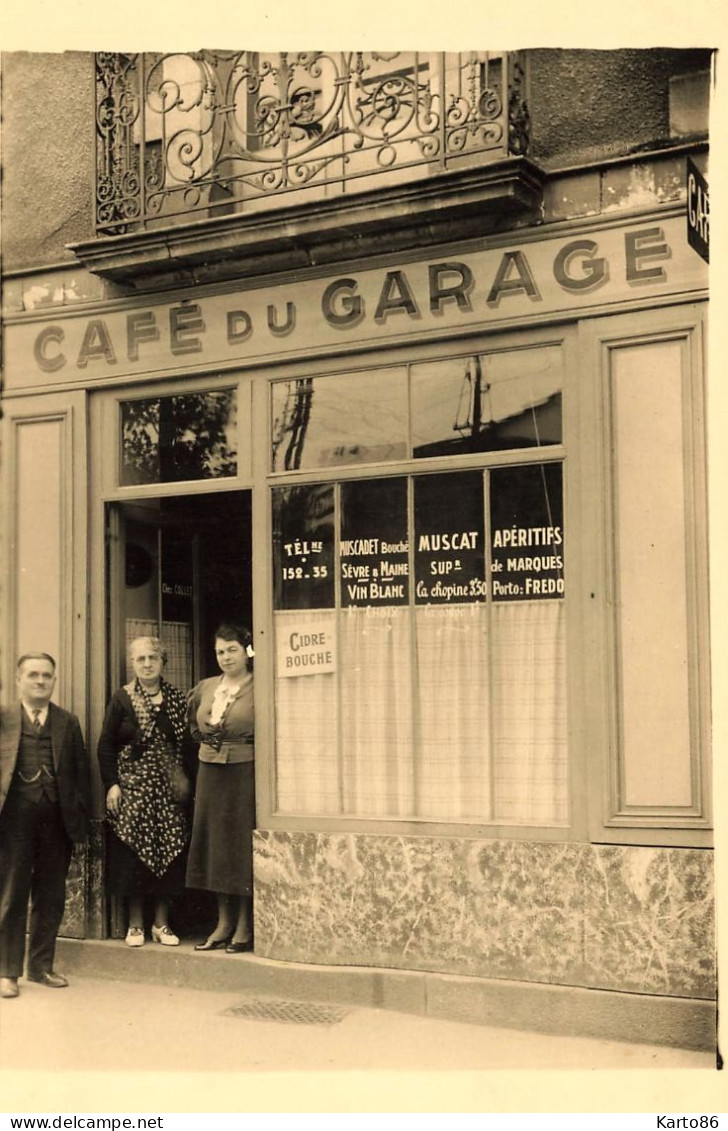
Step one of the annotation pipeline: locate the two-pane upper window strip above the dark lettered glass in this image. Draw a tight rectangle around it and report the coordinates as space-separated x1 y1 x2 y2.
271 346 563 472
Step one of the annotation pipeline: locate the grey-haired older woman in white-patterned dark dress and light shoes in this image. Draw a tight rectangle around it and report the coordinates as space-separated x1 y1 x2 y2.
98 637 193 947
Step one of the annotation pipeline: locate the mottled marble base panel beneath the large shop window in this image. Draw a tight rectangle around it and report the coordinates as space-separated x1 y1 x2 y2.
254 830 716 999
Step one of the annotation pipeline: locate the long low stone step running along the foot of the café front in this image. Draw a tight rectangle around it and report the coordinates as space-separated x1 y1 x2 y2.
55 939 717 1051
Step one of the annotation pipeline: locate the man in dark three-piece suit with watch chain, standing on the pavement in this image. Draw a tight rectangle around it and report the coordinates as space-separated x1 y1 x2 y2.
0 651 89 998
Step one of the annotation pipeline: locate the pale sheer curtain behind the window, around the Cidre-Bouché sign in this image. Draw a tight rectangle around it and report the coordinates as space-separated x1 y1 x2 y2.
270 601 567 824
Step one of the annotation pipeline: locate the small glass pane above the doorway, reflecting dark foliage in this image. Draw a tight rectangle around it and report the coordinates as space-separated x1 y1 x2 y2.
121 389 237 486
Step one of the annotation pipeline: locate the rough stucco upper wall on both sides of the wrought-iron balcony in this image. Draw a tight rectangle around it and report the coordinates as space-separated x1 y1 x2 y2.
1 49 710 271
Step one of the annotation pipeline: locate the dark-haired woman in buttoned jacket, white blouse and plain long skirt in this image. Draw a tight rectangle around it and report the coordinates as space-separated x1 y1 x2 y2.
187 623 255 953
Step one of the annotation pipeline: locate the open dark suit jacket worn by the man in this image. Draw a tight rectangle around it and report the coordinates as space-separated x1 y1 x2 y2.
0 703 90 841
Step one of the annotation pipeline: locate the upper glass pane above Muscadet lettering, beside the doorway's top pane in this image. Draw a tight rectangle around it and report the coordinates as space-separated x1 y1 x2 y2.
271 368 407 472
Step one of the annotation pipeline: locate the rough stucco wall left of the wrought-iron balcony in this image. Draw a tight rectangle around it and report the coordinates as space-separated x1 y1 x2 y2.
0 52 95 271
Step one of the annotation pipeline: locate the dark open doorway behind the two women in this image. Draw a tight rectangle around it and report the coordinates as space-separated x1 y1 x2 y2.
105 491 252 938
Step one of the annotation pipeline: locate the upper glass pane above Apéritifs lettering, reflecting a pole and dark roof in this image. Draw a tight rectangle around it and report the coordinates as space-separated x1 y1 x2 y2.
411 346 563 458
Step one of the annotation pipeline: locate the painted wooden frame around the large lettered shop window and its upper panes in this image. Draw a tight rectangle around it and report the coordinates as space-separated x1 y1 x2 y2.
253 321 587 841
